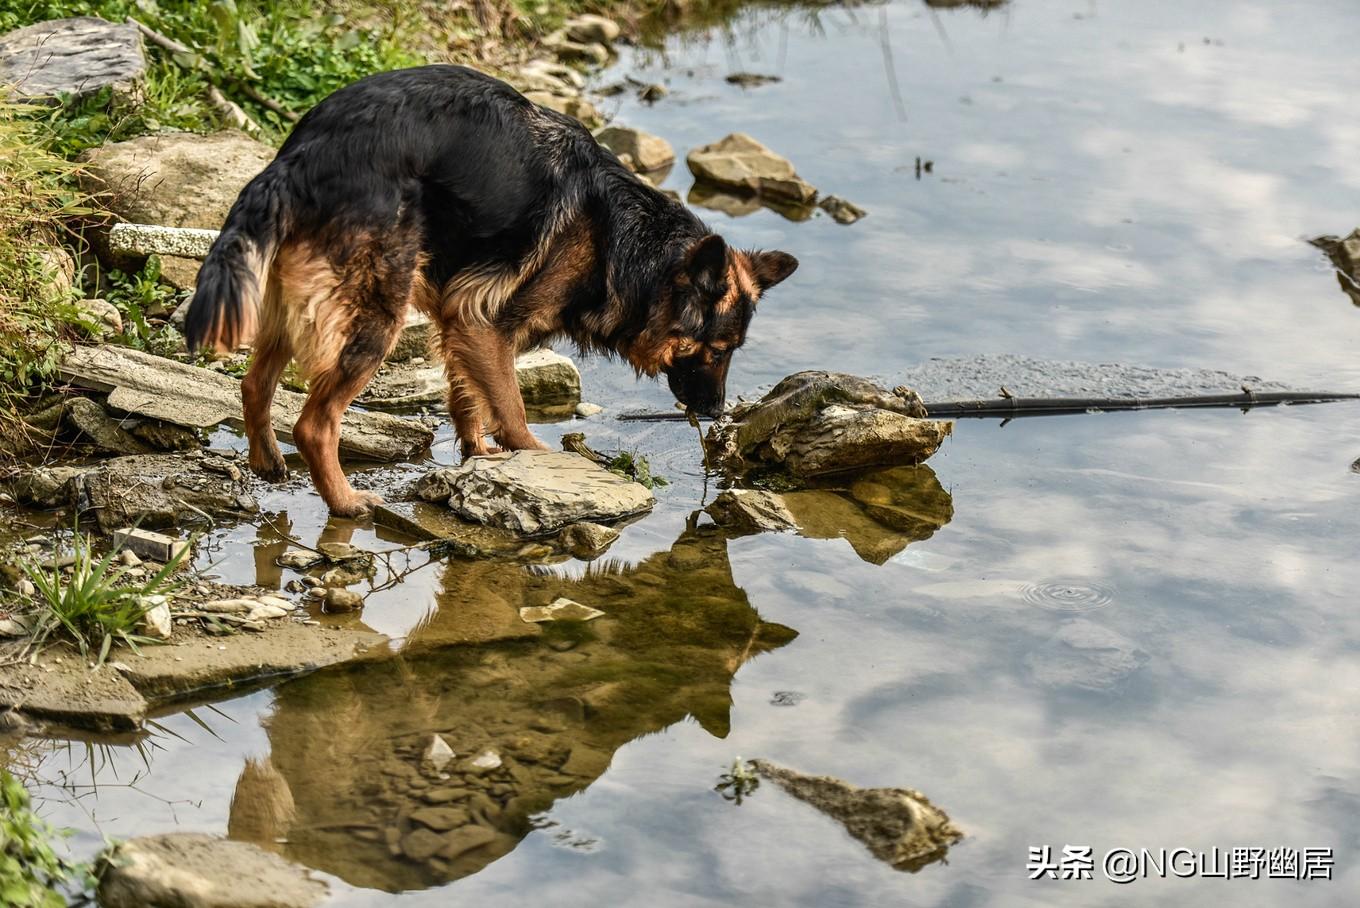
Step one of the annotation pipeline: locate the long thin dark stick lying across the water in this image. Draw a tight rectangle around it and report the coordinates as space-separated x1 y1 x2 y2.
619 391 1360 423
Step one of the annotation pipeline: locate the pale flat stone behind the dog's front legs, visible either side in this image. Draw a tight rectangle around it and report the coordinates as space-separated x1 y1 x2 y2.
359 349 581 409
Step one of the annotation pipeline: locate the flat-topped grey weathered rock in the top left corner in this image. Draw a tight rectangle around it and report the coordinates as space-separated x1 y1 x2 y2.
0 16 147 101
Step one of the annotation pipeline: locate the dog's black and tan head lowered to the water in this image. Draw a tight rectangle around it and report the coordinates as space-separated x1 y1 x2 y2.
631 234 798 416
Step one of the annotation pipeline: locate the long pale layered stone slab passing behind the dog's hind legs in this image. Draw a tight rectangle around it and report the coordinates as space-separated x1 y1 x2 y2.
60 347 434 461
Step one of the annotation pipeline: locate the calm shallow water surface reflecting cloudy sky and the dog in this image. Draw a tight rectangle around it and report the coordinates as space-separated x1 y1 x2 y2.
7 0 1360 907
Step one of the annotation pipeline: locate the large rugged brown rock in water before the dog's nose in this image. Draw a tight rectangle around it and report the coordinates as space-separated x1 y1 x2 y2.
707 371 953 478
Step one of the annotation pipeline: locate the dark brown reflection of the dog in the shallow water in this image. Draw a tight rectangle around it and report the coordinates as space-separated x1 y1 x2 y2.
228 526 797 892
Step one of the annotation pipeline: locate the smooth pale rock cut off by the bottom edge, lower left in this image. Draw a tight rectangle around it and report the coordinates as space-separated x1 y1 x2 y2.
99 832 328 908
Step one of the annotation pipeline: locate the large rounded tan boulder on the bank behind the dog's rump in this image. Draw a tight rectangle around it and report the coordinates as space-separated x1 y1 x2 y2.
82 130 275 228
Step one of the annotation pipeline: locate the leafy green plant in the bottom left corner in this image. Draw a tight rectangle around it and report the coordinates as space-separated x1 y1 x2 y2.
0 768 95 908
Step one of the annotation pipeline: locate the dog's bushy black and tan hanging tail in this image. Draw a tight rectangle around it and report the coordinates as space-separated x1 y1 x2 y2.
184 162 288 352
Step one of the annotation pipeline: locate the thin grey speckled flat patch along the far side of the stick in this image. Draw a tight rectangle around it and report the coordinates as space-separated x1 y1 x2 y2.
898 353 1292 409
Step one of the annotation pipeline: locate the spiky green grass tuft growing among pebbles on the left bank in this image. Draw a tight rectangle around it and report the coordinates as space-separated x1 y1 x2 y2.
19 527 189 665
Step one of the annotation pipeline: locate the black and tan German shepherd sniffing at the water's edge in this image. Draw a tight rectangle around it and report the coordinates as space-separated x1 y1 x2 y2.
185 65 798 517
